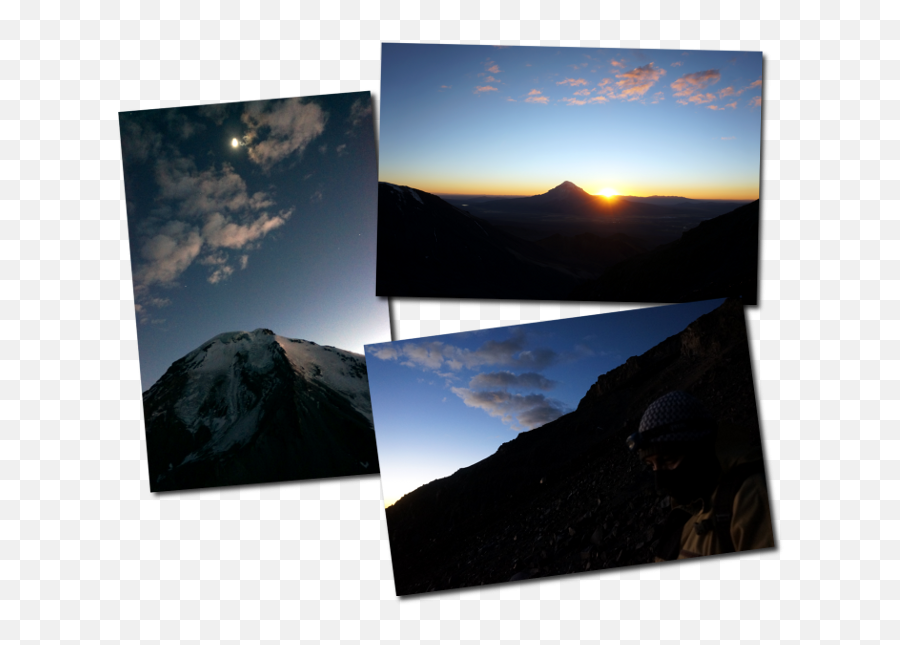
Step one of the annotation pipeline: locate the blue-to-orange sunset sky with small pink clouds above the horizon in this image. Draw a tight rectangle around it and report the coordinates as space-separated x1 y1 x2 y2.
379 43 762 199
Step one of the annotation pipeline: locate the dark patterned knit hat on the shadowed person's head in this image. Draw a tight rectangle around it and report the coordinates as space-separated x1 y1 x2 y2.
627 391 716 456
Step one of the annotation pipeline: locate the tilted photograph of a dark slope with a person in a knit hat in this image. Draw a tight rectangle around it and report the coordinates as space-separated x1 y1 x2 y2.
366 299 775 595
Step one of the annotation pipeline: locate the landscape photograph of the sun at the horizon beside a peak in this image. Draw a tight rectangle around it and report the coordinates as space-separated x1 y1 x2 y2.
376 43 762 305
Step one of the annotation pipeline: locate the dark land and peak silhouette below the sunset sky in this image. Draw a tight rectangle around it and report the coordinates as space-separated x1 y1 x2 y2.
376 182 759 305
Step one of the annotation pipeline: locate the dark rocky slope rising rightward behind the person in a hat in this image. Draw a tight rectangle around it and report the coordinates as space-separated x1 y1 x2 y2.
386 300 760 595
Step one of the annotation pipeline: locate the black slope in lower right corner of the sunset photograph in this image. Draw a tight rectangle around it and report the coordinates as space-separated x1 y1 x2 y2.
568 200 759 305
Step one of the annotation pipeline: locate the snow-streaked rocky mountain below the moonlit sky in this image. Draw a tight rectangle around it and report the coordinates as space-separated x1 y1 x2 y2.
144 329 379 492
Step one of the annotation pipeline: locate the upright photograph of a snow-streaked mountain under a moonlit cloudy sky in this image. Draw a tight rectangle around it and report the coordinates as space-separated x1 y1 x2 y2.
119 92 391 492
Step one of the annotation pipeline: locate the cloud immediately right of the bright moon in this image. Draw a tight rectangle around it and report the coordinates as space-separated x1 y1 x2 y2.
241 99 328 170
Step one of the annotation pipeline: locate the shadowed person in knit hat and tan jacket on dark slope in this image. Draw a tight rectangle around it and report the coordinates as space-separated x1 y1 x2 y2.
627 391 775 562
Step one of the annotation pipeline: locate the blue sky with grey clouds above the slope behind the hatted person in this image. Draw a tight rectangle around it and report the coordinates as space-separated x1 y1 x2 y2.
366 300 723 506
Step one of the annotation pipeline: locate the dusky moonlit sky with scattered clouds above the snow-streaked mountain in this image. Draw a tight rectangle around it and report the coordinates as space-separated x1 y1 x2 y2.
120 92 391 390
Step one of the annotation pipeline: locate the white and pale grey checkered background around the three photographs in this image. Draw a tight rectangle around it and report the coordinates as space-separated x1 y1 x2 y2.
0 0 900 643
